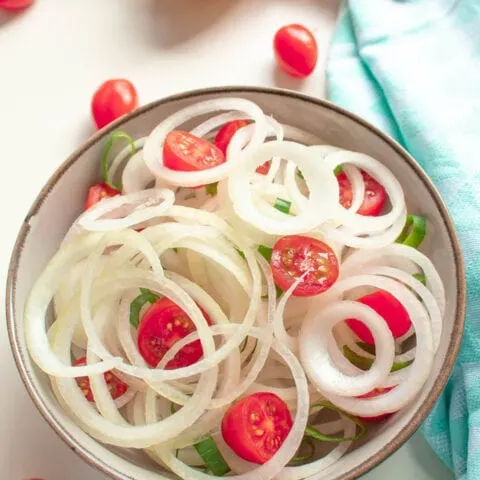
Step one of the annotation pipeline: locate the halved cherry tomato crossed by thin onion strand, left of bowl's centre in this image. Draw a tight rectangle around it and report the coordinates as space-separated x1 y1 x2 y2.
137 297 211 370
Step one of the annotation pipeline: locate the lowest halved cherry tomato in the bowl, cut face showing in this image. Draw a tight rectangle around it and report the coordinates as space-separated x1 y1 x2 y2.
222 392 293 464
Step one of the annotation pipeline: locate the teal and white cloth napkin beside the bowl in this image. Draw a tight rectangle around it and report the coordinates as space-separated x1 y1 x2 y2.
327 0 480 480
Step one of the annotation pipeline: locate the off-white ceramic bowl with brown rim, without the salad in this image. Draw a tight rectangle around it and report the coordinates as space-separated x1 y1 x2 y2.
6 87 465 480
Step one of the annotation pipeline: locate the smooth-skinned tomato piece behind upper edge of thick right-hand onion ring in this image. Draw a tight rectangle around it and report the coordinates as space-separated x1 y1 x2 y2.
347 290 412 345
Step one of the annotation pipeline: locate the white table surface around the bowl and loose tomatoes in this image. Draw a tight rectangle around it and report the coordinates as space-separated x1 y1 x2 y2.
0 0 453 480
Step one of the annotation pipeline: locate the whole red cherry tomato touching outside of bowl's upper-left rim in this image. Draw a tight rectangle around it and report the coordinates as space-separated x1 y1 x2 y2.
92 78 138 128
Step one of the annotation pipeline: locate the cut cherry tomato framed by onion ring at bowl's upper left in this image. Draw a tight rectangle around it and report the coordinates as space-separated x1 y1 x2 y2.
163 130 225 172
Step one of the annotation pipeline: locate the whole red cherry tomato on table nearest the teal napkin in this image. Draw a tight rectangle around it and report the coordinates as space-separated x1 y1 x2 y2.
273 24 318 78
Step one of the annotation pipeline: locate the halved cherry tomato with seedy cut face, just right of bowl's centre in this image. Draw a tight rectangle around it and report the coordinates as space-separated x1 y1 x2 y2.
270 235 338 297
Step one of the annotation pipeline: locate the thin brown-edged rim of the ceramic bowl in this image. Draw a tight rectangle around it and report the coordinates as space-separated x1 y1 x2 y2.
5 86 466 480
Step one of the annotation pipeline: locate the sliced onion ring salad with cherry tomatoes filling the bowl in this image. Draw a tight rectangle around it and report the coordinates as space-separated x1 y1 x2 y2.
24 98 445 480
